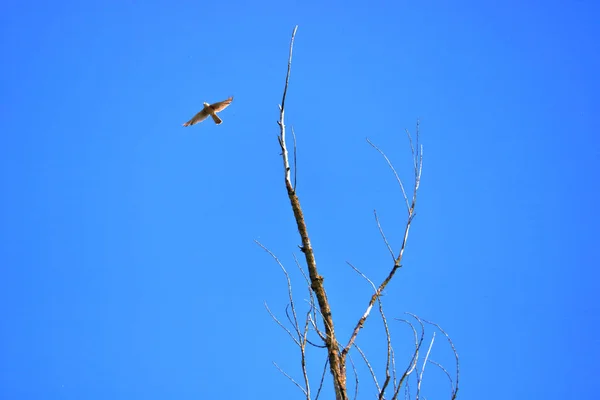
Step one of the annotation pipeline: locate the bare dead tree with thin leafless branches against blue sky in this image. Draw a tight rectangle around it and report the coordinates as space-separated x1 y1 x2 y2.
256 26 459 400
